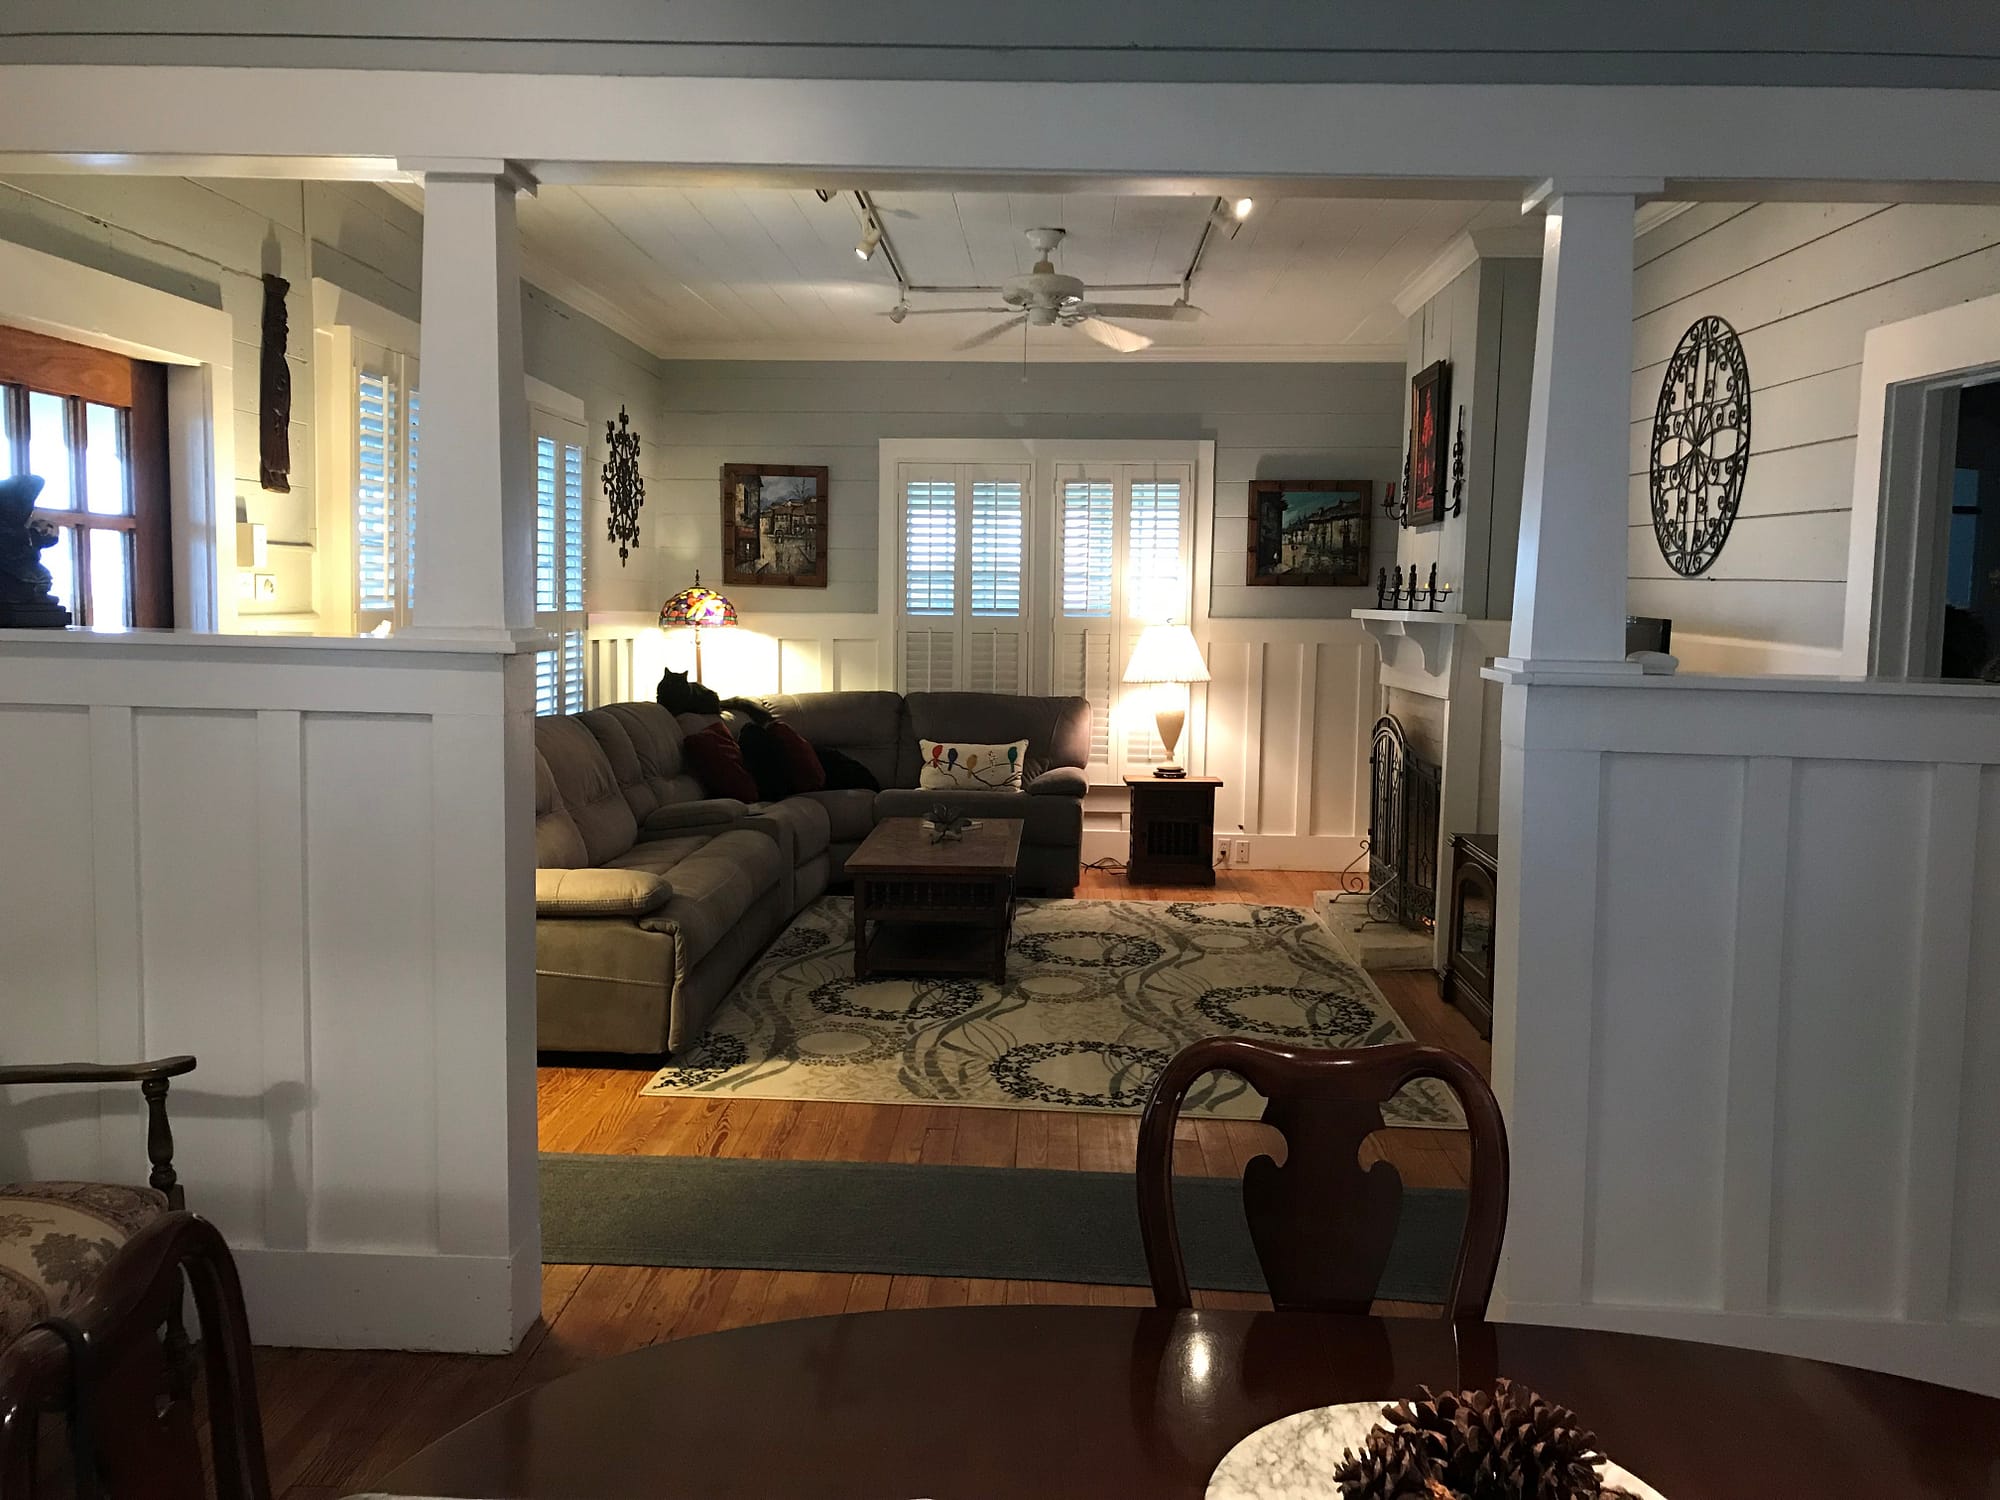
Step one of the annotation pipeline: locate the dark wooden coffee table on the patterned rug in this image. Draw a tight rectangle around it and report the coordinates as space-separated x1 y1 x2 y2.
848 818 1020 984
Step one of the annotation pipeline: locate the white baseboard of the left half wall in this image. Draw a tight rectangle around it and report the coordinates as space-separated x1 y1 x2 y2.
234 1246 542 1354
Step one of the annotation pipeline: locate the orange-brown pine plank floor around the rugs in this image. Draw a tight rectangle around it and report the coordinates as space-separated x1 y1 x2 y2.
256 870 1488 1500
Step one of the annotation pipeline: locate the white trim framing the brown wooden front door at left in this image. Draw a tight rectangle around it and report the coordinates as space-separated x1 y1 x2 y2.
0 240 236 630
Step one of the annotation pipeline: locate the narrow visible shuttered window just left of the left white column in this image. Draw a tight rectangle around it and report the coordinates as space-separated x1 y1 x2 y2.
354 338 422 632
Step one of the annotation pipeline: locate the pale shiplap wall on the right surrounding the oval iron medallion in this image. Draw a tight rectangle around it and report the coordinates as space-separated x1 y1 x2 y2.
1630 204 2000 672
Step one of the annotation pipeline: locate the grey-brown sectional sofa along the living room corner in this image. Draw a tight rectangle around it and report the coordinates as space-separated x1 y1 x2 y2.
534 692 1090 1054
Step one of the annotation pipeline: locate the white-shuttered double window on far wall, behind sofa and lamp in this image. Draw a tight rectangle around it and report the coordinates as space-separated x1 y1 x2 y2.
890 452 1194 780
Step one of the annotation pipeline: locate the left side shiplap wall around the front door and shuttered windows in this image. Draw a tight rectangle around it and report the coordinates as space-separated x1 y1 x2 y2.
0 176 660 634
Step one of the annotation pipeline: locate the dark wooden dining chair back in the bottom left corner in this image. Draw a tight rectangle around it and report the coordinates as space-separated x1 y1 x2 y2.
0 1212 270 1500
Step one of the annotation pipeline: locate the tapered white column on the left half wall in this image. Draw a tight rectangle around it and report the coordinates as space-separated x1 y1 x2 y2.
406 160 534 640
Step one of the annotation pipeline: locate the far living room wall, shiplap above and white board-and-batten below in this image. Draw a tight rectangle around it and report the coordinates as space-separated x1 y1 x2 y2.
590 360 1404 868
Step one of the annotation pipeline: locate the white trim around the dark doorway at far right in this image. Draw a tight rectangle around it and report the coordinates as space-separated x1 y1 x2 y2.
1840 294 2000 676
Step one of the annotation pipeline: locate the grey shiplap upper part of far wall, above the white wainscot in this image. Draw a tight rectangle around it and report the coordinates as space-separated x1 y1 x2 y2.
648 360 1402 620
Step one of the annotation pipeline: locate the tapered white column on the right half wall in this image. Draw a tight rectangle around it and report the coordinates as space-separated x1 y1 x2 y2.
1510 180 1662 672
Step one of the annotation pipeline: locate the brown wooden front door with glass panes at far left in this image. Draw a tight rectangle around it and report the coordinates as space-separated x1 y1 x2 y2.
0 328 174 628
